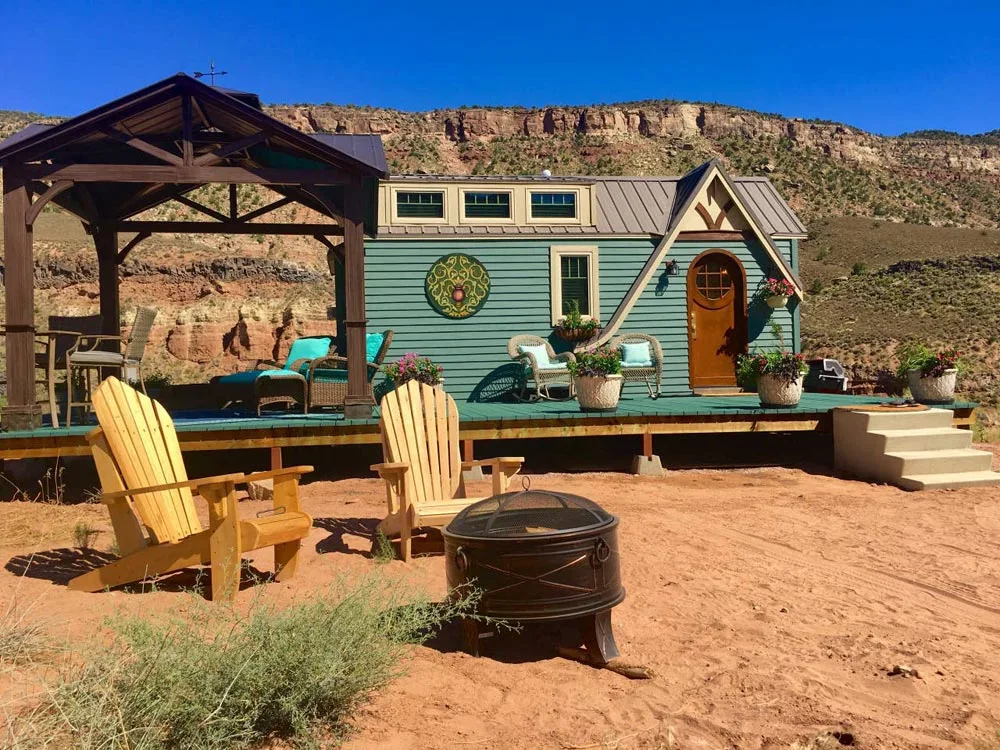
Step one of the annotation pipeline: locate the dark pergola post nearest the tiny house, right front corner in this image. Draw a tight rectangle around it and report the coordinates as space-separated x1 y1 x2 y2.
344 181 375 419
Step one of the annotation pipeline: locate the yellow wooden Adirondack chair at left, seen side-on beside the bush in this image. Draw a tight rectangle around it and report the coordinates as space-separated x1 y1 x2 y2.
69 378 312 600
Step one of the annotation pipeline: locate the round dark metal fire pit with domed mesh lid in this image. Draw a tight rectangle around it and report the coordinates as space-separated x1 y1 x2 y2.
442 482 625 662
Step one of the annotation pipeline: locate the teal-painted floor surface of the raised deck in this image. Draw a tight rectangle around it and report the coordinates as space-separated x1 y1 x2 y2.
0 393 976 441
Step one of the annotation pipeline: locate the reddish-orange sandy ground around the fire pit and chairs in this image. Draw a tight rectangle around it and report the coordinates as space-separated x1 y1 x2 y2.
0 458 1000 750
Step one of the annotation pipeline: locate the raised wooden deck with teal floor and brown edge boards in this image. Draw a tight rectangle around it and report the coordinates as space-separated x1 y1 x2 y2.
0 393 976 460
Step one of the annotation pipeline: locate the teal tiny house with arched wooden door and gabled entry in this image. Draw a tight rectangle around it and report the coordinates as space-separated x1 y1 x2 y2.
365 160 806 401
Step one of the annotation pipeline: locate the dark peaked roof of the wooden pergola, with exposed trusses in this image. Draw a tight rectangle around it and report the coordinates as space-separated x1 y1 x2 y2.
0 74 388 231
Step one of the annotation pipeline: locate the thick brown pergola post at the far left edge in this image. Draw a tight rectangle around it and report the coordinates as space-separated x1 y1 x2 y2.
3 168 42 430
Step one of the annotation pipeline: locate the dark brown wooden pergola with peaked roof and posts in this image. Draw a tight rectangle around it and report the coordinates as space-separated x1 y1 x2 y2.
0 74 387 429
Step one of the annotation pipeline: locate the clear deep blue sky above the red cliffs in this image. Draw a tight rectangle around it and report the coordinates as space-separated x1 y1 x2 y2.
0 0 1000 134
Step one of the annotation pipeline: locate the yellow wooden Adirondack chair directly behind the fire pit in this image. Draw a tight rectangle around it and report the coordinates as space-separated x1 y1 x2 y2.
371 380 524 561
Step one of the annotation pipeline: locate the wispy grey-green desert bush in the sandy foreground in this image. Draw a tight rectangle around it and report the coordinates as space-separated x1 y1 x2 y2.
21 577 475 750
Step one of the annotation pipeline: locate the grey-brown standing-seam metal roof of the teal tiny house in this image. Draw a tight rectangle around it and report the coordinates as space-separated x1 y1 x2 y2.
378 167 807 239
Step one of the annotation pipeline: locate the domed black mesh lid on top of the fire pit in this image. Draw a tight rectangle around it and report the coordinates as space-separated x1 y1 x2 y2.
447 481 614 538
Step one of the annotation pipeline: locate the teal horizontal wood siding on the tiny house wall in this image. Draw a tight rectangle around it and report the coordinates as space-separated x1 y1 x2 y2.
365 237 793 400
